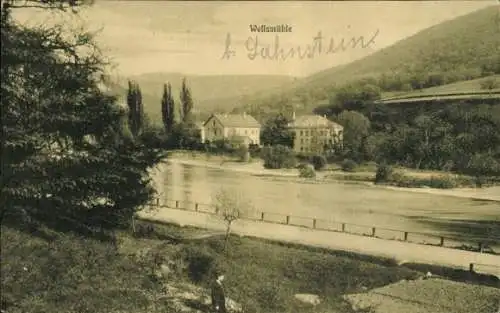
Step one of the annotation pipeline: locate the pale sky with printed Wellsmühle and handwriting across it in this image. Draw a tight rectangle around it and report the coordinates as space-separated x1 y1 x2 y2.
11 0 497 77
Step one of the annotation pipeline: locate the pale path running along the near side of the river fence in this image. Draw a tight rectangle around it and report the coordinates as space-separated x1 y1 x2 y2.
139 208 500 278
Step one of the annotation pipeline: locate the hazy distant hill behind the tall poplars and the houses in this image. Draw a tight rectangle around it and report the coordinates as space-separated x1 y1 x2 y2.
109 73 294 121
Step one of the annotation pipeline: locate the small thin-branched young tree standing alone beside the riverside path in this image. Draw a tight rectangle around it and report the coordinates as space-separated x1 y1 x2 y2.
212 189 252 250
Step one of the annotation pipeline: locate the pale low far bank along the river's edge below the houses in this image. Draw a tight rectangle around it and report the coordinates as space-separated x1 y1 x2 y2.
168 152 500 201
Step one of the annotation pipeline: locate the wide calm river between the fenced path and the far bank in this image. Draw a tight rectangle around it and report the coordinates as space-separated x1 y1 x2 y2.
154 163 500 246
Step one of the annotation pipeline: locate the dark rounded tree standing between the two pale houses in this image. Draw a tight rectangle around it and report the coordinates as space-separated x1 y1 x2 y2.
261 113 294 148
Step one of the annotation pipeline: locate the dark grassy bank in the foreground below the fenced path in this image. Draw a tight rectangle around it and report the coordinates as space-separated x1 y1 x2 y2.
2 221 426 313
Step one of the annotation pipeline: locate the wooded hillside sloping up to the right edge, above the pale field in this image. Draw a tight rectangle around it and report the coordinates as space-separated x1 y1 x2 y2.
301 6 500 86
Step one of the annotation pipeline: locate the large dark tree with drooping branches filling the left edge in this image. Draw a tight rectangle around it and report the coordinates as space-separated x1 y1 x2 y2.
0 1 164 235
